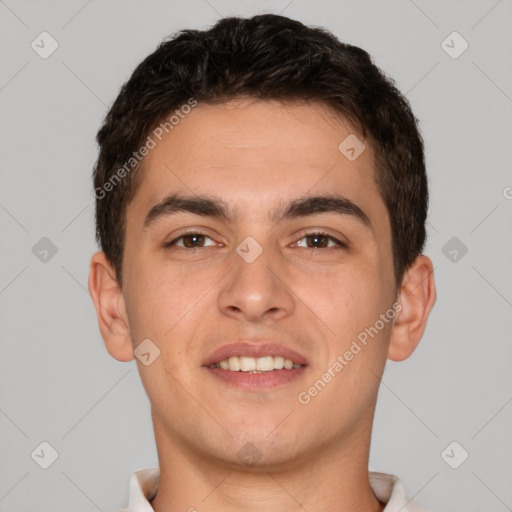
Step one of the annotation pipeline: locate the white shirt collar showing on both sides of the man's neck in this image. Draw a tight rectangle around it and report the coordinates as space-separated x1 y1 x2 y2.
119 468 425 512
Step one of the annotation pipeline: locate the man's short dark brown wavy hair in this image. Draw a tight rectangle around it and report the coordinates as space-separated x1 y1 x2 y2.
93 14 428 288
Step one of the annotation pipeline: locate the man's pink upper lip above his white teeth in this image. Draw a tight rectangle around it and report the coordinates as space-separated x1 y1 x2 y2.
203 341 308 366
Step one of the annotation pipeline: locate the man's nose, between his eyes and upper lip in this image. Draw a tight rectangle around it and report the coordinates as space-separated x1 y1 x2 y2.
218 242 296 322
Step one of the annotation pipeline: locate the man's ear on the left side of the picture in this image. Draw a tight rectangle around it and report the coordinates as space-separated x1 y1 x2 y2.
89 251 134 361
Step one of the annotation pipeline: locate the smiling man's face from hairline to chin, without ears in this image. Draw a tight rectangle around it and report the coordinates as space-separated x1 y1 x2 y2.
117 99 396 470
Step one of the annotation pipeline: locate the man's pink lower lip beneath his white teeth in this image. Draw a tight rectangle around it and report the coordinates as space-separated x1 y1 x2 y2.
204 366 306 391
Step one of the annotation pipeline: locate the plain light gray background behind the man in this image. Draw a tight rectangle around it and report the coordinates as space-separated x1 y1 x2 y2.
0 0 512 512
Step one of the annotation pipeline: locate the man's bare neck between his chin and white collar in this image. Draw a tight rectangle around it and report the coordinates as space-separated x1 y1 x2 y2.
151 411 384 512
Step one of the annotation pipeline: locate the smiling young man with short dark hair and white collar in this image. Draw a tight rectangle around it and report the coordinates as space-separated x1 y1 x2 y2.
89 15 435 512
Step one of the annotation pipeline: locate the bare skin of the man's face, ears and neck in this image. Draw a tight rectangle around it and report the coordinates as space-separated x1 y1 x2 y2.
89 98 435 512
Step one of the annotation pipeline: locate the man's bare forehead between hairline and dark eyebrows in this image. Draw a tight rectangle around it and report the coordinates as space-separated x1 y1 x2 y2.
128 98 382 230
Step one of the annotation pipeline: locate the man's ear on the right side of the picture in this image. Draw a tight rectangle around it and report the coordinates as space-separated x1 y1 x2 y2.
388 254 436 361
